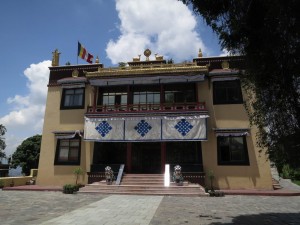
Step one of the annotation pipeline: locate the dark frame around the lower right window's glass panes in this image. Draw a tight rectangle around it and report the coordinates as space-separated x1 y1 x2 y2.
217 135 250 166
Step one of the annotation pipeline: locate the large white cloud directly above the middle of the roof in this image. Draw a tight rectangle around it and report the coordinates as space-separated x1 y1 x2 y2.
106 0 206 64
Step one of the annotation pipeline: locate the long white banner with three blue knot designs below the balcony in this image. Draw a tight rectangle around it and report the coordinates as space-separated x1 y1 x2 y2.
84 116 207 142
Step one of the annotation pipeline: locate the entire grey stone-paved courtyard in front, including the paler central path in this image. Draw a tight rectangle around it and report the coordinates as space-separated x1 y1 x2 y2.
0 191 300 225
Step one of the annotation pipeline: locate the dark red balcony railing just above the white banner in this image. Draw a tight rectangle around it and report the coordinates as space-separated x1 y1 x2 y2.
87 102 206 114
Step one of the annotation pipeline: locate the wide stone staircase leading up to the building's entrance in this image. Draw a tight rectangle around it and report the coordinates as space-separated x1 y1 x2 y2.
78 174 207 196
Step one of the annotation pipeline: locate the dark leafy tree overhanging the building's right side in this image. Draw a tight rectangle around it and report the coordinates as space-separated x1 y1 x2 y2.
182 0 300 167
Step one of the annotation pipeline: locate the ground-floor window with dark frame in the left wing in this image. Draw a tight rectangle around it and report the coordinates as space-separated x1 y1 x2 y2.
54 138 80 165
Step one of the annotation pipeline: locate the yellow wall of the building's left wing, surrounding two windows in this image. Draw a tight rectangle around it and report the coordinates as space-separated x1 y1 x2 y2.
37 87 93 185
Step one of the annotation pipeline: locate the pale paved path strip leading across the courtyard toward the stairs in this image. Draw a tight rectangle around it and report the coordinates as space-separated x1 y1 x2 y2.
42 195 163 225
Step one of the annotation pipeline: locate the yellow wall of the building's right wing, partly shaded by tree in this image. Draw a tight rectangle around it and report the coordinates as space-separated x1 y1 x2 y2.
198 80 272 190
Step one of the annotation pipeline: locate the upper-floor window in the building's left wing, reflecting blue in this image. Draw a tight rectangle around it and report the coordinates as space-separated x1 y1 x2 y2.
60 88 84 109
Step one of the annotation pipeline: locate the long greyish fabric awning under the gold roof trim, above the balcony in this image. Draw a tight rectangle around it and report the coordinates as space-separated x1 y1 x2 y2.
90 74 204 86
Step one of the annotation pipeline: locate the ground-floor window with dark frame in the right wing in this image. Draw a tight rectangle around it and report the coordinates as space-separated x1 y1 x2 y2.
217 136 249 165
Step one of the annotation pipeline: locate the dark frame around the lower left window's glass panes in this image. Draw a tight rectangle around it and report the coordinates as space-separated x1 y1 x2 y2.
54 136 81 165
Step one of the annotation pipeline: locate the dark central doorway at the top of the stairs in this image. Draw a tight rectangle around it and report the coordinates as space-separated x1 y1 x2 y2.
131 142 161 174
